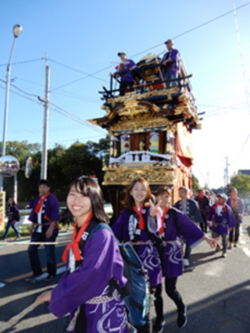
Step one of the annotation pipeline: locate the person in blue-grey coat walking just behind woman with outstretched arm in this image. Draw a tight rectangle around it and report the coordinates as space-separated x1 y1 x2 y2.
174 186 202 267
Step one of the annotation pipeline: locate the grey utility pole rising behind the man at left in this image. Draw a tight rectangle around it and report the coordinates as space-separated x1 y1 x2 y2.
40 53 50 179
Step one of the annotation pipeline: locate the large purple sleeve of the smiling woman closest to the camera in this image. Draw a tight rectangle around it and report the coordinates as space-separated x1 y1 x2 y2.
49 229 127 317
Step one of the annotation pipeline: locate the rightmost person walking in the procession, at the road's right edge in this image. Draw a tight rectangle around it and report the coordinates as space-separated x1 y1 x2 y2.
227 188 244 250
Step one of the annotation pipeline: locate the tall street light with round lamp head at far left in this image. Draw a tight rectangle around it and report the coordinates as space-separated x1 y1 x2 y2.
0 24 23 191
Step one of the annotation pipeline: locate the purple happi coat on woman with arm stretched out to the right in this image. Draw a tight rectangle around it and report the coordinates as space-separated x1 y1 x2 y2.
163 208 204 278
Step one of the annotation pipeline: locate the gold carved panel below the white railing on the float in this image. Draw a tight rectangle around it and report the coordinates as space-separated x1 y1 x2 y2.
103 166 175 185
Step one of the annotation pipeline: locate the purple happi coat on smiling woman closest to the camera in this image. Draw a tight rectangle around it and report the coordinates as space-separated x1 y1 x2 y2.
49 220 128 333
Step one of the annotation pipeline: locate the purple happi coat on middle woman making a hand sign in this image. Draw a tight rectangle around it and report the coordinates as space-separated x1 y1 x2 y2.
112 208 162 287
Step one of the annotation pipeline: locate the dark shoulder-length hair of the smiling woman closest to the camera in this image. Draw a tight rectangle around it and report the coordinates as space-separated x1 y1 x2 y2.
64 176 109 223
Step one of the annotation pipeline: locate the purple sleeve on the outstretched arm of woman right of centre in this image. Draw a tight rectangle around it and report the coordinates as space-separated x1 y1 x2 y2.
177 211 204 246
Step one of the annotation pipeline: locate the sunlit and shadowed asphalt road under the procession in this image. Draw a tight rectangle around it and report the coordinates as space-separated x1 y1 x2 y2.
0 217 250 333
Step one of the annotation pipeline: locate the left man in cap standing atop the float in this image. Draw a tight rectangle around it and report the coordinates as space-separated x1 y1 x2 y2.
114 52 136 96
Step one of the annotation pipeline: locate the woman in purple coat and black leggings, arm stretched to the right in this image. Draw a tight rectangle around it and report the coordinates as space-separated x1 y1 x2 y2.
156 186 220 327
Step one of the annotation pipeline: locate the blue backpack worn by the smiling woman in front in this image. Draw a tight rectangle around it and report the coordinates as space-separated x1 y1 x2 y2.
89 223 149 327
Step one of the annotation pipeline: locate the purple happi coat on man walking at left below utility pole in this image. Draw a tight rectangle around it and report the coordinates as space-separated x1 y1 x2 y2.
29 193 60 236
